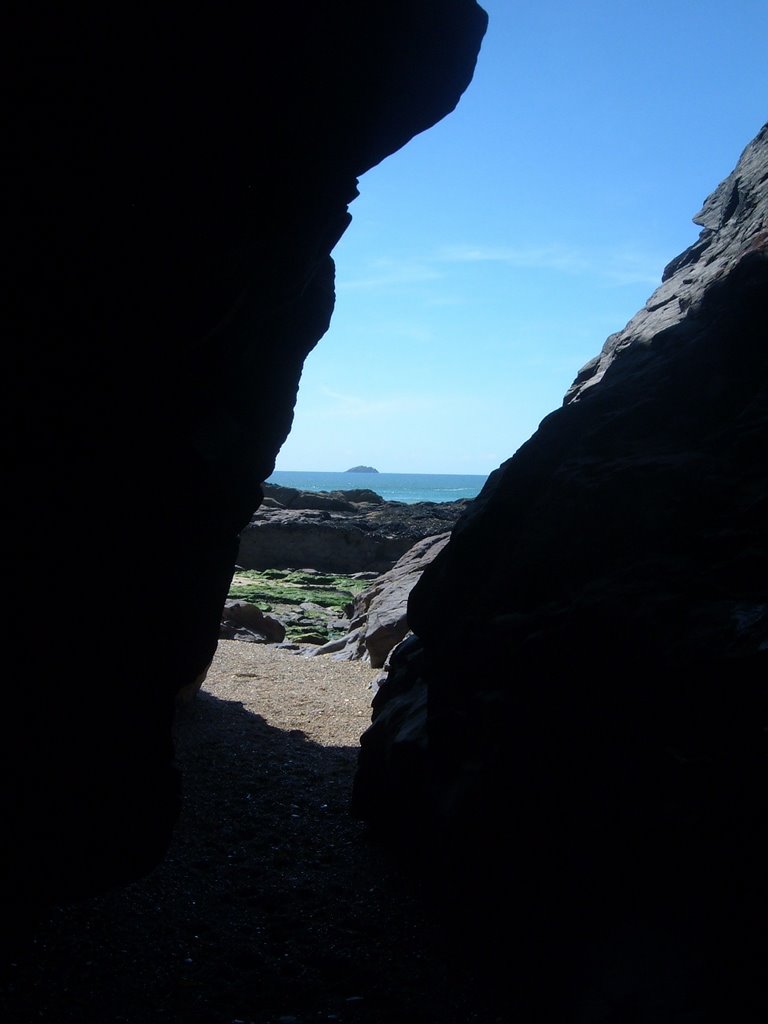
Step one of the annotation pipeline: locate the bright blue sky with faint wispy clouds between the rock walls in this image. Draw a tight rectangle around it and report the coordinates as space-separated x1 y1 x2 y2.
276 0 768 474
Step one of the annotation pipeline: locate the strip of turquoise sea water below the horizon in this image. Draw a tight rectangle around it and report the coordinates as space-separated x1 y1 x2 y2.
267 470 487 505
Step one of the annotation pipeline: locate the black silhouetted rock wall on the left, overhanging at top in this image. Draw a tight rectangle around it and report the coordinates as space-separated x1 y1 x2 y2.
1 0 486 920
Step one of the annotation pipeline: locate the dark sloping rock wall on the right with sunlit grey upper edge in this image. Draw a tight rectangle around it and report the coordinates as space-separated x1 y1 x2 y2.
355 119 768 1021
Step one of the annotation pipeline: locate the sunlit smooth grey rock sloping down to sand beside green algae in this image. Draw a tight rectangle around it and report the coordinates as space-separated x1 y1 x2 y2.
311 531 451 667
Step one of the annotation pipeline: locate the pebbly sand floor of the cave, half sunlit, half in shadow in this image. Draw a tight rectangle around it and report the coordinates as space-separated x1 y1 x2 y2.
0 640 501 1024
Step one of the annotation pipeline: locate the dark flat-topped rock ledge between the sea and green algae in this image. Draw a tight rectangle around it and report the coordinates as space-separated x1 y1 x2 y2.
238 488 470 572
